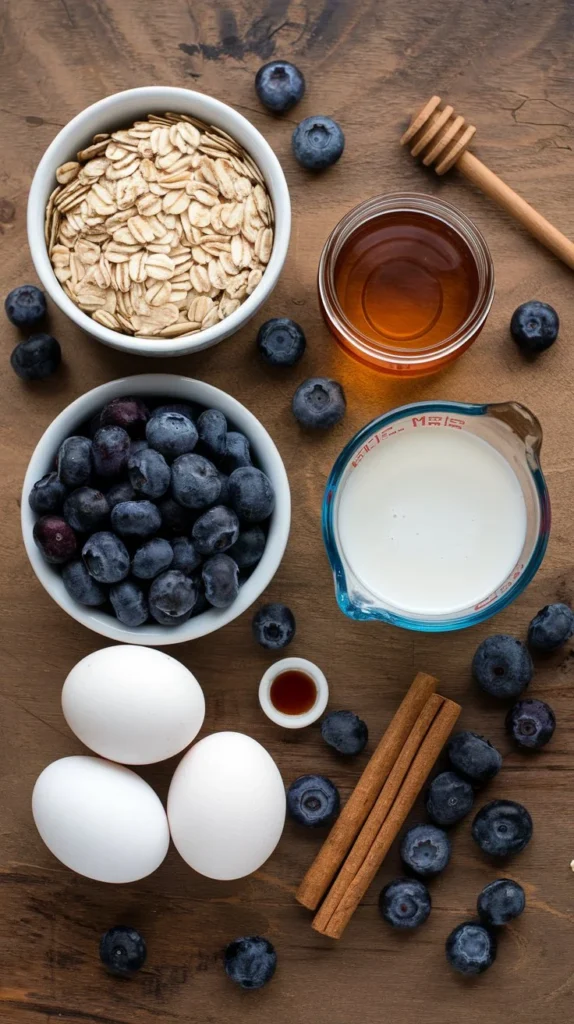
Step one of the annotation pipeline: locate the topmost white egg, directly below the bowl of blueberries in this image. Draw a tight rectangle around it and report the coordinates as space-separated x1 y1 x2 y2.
61 644 206 765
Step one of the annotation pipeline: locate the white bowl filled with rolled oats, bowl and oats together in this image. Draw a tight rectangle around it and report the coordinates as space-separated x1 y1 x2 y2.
28 86 291 356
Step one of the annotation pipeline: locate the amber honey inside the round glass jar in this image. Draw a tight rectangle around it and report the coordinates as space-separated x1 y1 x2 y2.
335 211 479 351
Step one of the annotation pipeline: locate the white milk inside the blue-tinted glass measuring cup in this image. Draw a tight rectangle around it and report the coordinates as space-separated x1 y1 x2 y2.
337 428 527 615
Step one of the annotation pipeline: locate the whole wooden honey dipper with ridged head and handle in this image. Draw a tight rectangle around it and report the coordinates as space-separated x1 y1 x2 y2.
401 96 574 270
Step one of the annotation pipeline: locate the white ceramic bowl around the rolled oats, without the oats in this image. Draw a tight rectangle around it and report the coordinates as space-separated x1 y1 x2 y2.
28 85 291 356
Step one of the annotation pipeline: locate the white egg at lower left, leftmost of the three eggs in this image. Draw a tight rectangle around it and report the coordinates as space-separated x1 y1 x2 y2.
32 757 170 882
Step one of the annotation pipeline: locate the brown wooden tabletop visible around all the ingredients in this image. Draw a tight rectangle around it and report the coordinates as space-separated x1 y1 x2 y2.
0 0 574 1024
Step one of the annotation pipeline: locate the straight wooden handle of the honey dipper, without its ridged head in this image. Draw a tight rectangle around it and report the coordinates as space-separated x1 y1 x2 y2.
456 151 574 270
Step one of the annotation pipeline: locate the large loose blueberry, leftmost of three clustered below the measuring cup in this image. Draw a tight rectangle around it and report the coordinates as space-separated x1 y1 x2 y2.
473 634 534 698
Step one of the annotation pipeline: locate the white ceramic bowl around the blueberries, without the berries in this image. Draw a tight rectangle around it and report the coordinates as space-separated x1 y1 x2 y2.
21 374 291 646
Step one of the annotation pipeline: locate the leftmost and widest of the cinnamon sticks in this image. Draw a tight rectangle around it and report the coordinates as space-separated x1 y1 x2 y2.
297 672 438 910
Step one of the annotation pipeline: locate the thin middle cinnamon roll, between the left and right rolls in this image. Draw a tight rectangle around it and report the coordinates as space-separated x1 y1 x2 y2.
313 693 444 932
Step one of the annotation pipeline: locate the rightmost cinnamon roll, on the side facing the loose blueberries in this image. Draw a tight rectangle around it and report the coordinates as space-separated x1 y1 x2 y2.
315 699 460 939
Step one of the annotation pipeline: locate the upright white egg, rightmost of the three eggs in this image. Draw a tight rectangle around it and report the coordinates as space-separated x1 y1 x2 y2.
168 732 285 880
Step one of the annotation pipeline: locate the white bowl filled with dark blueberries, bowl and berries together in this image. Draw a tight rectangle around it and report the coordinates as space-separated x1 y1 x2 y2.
21 374 291 645
